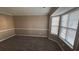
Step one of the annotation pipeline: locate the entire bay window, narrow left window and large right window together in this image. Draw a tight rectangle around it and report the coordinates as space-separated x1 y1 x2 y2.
51 8 79 48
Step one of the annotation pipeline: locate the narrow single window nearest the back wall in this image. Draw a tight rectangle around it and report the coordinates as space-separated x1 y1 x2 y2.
51 17 59 35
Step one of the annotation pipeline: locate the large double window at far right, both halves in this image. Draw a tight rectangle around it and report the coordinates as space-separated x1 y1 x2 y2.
59 10 79 48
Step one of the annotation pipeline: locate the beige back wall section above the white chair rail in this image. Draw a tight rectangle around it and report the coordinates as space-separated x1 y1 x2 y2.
14 16 48 29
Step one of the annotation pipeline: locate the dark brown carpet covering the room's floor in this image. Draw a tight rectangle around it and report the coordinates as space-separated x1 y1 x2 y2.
0 36 61 51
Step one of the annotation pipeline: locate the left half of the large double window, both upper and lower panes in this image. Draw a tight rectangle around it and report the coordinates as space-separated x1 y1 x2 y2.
59 14 68 40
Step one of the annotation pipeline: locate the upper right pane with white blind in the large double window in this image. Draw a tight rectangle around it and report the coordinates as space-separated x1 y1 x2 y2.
68 10 79 29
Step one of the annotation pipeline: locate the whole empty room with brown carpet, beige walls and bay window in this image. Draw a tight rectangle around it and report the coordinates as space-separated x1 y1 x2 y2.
0 7 79 51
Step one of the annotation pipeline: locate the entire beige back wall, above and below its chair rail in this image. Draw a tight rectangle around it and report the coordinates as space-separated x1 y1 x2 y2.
14 16 48 36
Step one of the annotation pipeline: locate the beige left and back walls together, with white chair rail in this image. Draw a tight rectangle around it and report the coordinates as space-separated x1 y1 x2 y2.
0 15 48 41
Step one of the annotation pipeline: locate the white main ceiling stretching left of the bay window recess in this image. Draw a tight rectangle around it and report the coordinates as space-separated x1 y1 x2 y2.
0 7 50 15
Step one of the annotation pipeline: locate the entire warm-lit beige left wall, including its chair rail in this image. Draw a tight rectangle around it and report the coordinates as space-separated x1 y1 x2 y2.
0 15 14 40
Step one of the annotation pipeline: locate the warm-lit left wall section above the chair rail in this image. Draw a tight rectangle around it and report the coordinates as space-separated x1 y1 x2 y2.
0 15 14 30
